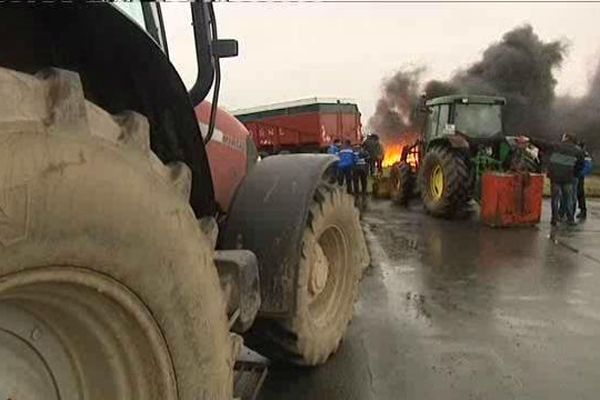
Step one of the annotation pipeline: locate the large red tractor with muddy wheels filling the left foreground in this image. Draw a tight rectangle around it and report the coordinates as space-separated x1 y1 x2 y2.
0 2 368 400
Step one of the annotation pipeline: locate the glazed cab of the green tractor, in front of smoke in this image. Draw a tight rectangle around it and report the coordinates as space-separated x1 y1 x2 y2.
425 95 506 142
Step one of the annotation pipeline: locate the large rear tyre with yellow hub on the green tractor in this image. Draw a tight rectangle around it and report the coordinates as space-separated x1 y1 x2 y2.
419 147 472 218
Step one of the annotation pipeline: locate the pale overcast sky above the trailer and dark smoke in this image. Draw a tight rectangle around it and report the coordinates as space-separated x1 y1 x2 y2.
163 3 600 124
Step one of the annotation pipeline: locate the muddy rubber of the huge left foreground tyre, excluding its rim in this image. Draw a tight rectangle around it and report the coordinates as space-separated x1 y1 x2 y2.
0 68 236 400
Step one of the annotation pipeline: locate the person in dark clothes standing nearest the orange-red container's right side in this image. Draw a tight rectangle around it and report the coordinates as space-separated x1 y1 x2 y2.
531 133 583 226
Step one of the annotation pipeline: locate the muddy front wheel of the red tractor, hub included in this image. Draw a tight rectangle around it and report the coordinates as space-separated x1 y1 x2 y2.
251 184 369 366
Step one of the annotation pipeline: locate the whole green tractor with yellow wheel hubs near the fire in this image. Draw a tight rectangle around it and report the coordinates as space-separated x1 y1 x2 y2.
390 95 540 218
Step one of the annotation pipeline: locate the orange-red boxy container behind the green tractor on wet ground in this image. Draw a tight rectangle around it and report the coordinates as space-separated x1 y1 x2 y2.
481 172 544 227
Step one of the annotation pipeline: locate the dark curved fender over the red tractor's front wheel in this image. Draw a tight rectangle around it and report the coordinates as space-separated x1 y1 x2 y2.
219 154 337 317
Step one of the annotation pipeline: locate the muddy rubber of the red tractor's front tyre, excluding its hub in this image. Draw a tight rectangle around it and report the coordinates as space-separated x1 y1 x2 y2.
249 181 369 366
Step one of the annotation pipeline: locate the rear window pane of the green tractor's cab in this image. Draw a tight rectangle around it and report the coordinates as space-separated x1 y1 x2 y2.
454 103 502 137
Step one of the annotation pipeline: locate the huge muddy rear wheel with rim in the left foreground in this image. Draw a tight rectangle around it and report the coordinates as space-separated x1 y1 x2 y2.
0 69 234 400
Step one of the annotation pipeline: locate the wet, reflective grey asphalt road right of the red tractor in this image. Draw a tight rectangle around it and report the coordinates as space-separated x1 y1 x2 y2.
259 201 600 400
